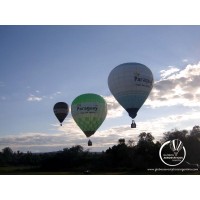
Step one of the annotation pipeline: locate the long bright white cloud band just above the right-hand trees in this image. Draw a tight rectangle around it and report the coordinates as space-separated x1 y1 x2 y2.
95 110 200 145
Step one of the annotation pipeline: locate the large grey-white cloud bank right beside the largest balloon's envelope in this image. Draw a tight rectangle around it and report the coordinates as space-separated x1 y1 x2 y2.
145 62 200 108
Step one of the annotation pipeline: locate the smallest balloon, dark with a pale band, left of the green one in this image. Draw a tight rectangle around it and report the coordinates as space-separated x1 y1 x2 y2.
53 102 69 126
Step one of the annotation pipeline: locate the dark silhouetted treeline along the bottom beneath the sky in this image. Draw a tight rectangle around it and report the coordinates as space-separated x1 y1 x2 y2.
0 126 200 174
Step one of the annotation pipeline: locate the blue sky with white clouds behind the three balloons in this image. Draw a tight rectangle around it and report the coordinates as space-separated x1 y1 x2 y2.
0 25 200 152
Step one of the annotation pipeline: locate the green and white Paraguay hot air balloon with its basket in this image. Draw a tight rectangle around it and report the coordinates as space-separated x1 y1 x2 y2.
71 93 107 146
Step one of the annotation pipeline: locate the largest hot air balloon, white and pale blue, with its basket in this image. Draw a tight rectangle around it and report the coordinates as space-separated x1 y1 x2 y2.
108 63 153 128
